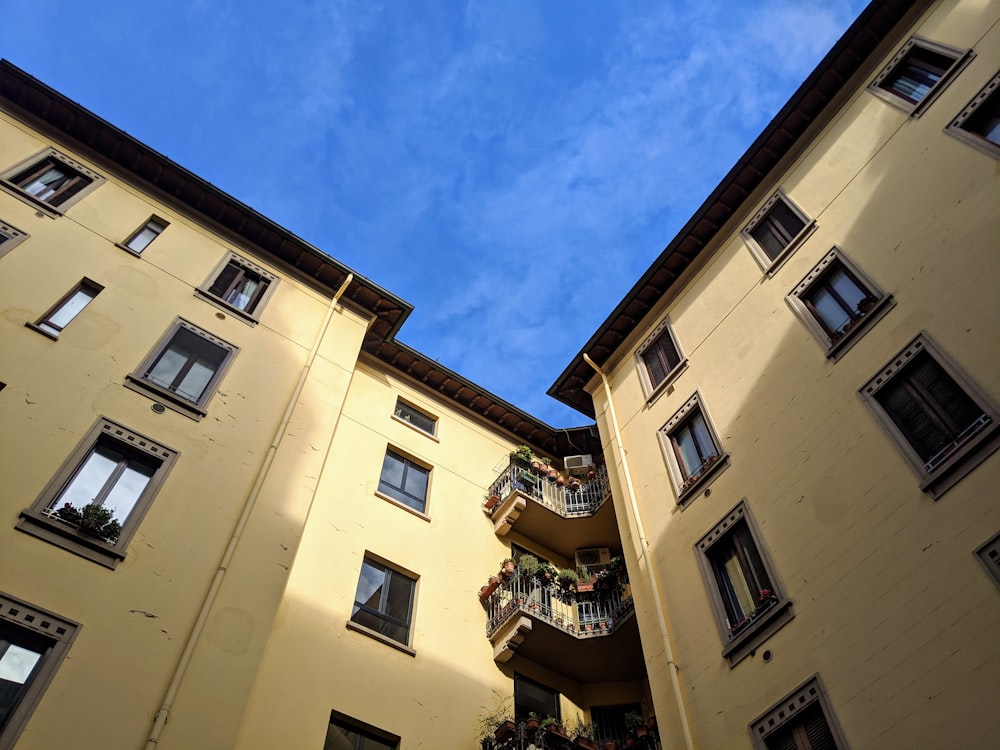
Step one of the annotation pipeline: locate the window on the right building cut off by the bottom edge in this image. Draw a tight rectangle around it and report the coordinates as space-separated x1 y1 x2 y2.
750 675 847 750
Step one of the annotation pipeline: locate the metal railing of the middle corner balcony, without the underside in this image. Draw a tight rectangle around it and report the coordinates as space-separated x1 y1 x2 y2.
483 573 633 638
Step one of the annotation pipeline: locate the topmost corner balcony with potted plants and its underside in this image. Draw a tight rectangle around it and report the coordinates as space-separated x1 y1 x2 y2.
483 459 620 557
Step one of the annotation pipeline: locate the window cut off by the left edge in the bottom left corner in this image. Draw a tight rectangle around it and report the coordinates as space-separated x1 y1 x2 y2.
0 593 80 748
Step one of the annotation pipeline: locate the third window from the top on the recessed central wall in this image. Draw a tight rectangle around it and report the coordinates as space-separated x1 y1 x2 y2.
351 555 417 646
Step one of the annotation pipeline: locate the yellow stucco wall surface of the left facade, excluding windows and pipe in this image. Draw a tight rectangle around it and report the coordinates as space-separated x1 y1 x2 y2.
0 107 368 748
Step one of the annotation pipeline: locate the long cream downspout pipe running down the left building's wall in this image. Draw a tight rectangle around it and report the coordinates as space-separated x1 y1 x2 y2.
144 273 354 750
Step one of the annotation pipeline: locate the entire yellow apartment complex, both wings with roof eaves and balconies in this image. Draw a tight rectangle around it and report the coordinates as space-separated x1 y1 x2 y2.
0 0 1000 750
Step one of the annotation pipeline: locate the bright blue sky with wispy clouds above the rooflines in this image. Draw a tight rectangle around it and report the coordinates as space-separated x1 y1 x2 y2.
0 0 865 426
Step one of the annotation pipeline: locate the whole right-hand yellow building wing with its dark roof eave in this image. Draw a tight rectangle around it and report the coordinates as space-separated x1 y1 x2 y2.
552 0 1000 750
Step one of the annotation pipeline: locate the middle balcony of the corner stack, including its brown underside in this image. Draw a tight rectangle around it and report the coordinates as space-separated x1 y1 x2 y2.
481 571 645 682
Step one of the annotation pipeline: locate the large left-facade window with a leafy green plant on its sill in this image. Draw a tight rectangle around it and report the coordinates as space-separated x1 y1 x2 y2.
17 418 177 568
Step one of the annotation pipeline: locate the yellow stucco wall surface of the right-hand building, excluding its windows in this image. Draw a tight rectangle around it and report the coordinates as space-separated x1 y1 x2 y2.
591 0 1000 750
